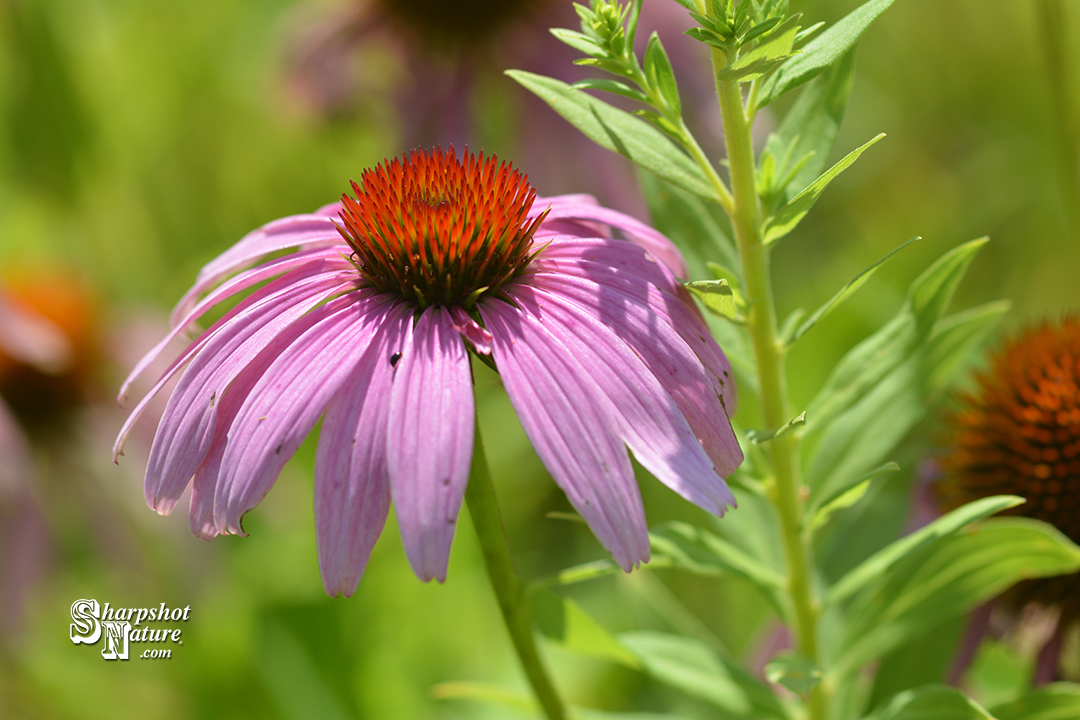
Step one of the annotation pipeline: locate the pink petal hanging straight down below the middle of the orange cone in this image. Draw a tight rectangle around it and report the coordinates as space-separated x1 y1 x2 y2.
387 305 475 582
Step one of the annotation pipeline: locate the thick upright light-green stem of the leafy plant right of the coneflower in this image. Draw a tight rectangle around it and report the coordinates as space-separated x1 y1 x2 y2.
713 49 827 720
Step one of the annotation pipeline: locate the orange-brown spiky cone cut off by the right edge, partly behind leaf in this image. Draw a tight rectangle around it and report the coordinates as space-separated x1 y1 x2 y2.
939 316 1080 623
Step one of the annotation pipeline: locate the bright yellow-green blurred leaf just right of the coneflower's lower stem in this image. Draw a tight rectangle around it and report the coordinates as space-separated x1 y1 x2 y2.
532 588 642 668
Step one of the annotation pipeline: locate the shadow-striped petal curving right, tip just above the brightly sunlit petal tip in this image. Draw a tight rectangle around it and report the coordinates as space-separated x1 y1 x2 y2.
524 262 743 477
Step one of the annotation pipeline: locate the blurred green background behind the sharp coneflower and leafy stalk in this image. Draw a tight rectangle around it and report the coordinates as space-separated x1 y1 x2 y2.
0 0 1080 719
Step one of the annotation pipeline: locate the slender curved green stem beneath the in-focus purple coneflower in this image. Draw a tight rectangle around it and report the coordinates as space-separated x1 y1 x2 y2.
465 423 567 720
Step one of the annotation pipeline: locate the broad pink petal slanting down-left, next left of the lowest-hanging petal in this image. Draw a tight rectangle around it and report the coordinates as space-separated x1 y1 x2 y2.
214 290 393 533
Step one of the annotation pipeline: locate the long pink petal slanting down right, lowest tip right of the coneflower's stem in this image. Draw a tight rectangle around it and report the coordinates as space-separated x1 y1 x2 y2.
480 299 649 571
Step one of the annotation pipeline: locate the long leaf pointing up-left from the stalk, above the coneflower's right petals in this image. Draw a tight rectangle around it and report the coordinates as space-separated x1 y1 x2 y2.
507 70 719 203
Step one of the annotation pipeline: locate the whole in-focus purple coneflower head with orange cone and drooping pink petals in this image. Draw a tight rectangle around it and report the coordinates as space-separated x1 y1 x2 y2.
114 150 742 595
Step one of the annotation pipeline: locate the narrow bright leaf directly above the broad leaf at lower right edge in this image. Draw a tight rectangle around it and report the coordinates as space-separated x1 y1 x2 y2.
825 495 1024 604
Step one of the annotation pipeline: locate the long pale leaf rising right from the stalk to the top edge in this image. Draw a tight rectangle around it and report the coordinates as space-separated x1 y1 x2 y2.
757 0 893 108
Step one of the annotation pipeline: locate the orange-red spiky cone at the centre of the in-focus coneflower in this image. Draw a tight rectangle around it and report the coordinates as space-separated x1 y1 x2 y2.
338 148 544 310
